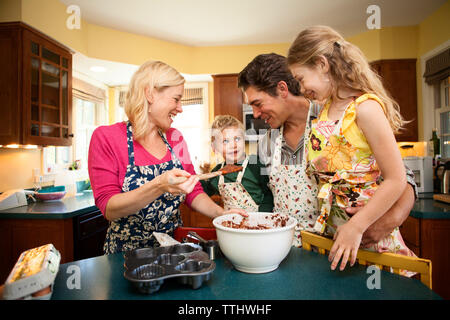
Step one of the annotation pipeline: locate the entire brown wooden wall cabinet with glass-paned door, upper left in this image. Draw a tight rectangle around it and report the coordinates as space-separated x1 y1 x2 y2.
0 22 73 146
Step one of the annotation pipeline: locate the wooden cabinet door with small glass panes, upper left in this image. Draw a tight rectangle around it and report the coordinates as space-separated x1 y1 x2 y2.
22 30 72 146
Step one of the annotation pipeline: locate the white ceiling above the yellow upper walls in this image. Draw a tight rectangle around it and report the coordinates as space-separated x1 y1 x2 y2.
60 0 445 46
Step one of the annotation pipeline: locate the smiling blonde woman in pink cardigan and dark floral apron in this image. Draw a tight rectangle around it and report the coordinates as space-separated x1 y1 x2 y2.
88 61 244 254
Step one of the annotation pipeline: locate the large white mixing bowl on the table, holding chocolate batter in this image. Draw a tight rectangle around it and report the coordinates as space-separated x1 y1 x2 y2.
213 212 297 273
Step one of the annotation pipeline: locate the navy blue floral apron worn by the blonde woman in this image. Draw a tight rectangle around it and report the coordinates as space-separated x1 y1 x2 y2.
103 122 186 254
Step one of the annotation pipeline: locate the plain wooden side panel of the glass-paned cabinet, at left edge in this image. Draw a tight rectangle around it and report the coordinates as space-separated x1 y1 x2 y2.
0 27 22 145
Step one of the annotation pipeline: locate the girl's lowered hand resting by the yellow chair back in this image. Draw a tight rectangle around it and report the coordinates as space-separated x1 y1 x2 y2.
328 220 363 271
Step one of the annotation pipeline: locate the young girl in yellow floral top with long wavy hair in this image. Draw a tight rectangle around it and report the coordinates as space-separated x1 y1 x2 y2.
288 26 414 270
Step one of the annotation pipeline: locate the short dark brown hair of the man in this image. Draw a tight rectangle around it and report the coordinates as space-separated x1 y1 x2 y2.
238 53 301 97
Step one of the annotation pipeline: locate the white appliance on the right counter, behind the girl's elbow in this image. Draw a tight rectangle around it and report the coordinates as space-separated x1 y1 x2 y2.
403 157 434 193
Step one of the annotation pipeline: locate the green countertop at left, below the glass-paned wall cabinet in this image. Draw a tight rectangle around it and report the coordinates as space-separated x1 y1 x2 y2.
0 191 98 219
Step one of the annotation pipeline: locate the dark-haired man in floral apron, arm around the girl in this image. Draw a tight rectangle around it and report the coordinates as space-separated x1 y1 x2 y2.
238 53 417 246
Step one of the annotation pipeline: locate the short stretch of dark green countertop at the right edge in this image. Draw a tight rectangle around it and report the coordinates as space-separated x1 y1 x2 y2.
409 193 450 219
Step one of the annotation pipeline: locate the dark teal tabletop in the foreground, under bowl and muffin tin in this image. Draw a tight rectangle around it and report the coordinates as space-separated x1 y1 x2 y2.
52 247 441 300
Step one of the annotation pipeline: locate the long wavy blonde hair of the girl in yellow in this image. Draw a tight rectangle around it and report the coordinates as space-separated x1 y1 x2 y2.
287 26 405 132
